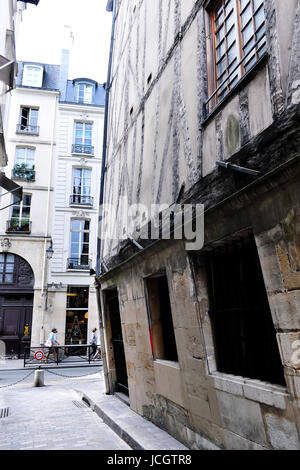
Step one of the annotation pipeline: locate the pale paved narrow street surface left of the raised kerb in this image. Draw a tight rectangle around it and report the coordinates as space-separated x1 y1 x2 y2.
0 368 130 450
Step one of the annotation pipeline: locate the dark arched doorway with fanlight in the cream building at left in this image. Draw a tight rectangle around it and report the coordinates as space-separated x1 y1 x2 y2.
0 253 34 358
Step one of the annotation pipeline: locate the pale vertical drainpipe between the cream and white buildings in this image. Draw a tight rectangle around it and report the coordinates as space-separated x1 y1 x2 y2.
40 95 58 345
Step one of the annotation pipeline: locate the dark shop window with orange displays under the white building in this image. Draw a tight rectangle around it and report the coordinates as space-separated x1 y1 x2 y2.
65 286 89 344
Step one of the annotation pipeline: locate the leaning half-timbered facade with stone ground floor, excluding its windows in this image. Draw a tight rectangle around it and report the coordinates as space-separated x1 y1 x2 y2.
97 0 300 449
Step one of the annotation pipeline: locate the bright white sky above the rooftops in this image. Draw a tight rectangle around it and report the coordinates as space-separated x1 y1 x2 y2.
16 0 112 83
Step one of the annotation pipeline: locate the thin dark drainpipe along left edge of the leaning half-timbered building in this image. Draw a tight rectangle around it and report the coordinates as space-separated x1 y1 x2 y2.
95 1 116 395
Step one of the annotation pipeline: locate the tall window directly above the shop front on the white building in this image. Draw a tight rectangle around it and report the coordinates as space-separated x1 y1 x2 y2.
68 219 90 269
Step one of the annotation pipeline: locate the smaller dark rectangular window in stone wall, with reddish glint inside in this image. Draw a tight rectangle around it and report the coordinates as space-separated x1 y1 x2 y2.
146 275 178 361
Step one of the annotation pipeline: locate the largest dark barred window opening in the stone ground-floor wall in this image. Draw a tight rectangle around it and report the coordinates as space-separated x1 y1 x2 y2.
206 232 285 385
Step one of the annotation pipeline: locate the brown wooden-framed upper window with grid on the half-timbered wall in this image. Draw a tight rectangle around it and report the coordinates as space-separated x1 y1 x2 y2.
210 0 266 106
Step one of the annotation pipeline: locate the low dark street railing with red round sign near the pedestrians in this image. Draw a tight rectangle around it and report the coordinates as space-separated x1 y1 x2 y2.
24 344 101 367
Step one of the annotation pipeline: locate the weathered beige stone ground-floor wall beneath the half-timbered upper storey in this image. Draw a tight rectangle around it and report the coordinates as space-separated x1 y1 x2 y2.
101 162 300 449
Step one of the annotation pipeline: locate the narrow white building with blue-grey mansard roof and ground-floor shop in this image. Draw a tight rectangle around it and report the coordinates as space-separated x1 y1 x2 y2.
45 50 105 344
